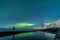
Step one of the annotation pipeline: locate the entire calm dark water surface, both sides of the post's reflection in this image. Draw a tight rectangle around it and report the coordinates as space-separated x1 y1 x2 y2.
0 32 54 40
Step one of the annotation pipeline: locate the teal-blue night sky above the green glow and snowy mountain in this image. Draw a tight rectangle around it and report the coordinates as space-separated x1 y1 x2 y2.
0 0 60 26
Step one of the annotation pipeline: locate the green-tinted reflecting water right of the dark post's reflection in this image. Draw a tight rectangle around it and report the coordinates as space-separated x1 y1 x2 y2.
15 32 54 40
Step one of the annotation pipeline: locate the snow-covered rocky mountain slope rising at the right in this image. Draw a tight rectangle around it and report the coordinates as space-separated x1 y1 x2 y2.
34 19 60 29
